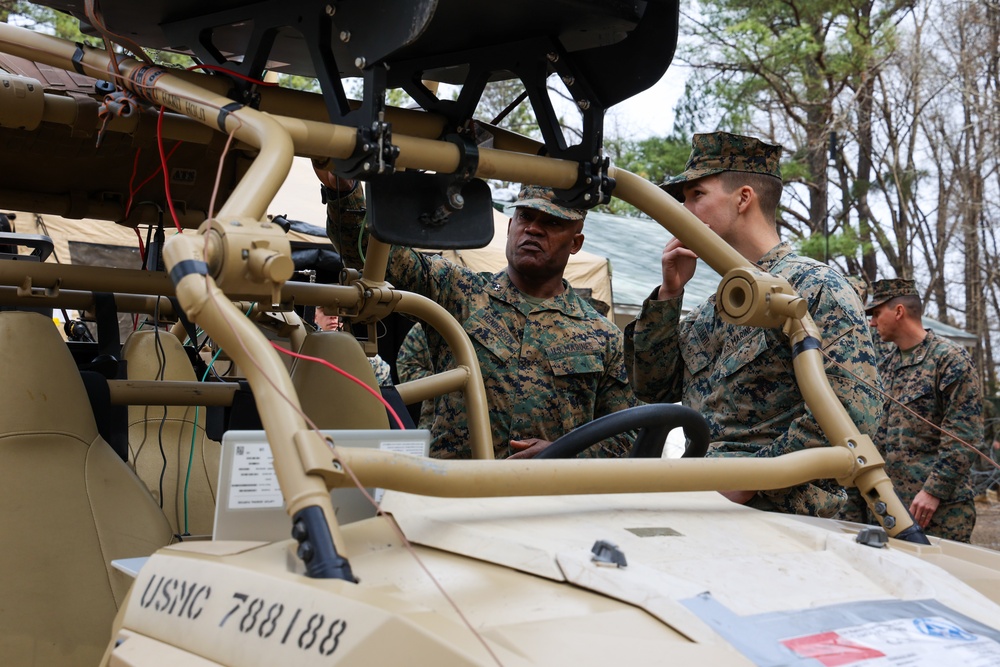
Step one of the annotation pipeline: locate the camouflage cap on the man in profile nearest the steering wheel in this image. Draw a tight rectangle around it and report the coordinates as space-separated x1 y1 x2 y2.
660 132 781 201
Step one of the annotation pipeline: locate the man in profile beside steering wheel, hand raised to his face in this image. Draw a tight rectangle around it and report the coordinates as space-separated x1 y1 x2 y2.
625 132 881 517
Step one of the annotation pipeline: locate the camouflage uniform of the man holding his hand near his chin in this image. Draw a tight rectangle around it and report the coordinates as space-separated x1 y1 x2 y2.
625 243 880 517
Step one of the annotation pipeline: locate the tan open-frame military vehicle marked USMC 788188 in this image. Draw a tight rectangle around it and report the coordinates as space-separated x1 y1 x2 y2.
0 0 1000 665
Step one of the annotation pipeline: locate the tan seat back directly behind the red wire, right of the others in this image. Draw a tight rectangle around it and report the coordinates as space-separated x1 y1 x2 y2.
291 331 389 429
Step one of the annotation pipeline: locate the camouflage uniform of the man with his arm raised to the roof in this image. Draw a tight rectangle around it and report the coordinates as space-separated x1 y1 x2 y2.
327 189 636 458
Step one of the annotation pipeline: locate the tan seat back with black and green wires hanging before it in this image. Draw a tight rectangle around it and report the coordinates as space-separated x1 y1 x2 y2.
122 330 221 535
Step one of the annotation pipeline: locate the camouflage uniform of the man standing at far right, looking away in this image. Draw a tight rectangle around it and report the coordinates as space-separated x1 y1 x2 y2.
875 330 983 542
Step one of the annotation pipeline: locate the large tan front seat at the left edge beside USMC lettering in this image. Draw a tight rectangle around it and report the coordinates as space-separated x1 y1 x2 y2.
0 312 171 666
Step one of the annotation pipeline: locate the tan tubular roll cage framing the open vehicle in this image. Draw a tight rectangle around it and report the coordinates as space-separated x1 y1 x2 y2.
0 24 913 544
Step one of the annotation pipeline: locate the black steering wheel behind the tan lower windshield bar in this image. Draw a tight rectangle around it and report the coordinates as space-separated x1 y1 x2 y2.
535 403 710 459
